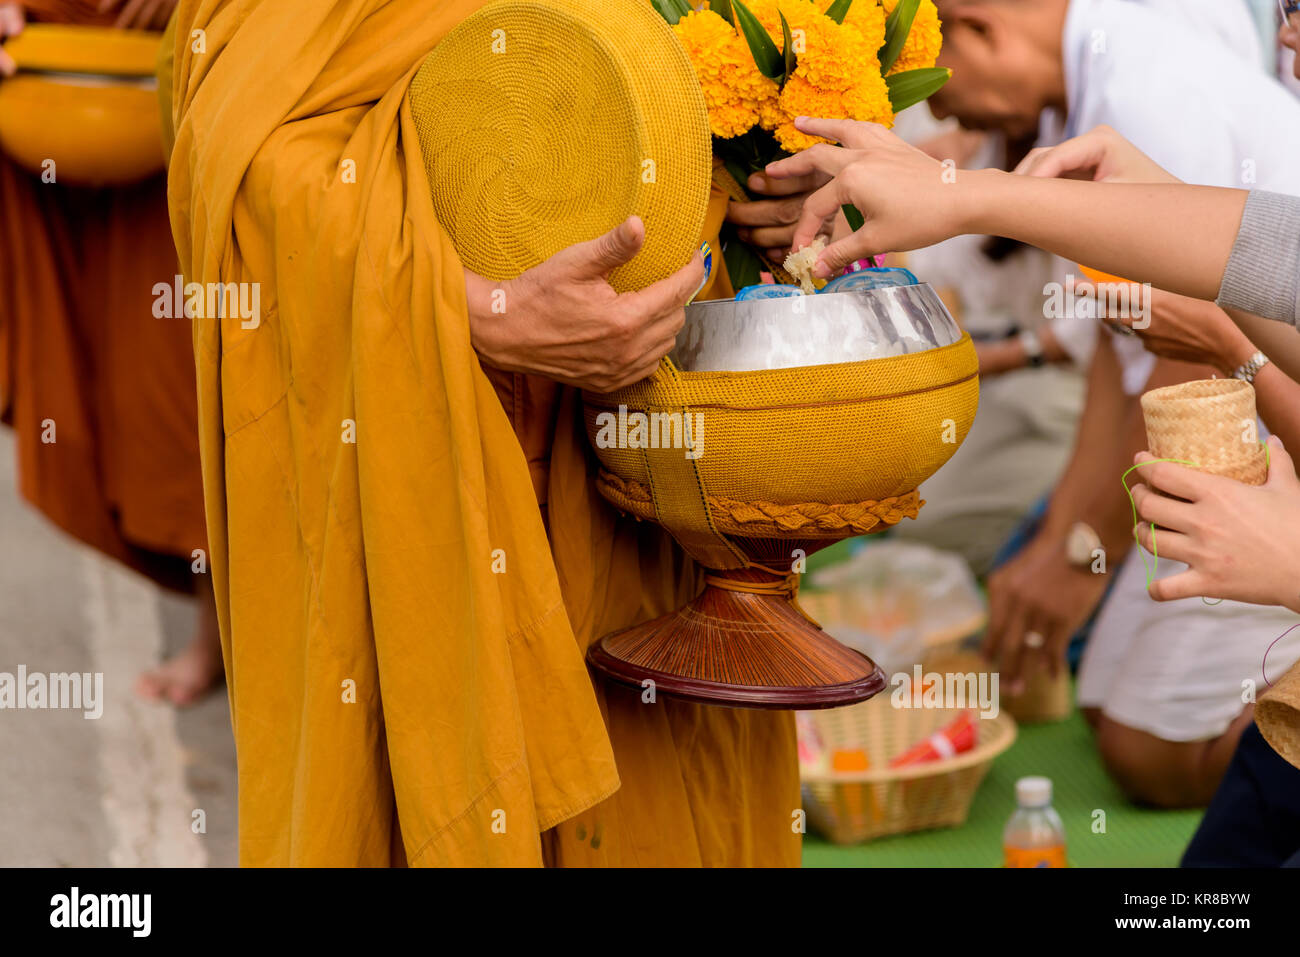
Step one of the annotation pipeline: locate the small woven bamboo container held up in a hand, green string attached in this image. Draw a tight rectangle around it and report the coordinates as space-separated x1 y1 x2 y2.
1141 378 1269 485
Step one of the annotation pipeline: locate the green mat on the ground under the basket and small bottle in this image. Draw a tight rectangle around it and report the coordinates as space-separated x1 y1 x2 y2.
803 713 1201 867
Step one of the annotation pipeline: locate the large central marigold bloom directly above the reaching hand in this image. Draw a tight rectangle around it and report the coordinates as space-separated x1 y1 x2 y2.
748 0 893 152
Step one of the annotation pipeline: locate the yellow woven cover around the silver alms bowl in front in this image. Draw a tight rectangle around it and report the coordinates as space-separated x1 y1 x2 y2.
584 337 979 512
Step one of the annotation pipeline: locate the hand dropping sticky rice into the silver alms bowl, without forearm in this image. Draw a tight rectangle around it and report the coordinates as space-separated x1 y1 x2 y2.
766 116 967 278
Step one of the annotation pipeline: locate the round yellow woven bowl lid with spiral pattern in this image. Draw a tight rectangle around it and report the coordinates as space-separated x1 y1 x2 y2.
410 0 712 291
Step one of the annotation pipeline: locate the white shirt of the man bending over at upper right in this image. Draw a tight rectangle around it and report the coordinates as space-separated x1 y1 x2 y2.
1040 0 1300 394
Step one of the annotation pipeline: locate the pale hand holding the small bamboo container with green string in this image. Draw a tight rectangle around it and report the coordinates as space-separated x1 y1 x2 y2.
1132 436 1300 611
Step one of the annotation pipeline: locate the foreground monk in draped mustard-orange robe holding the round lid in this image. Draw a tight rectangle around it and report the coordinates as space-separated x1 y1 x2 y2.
169 0 801 866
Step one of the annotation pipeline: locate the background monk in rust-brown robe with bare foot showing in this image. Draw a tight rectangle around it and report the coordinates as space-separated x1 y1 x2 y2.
0 0 221 705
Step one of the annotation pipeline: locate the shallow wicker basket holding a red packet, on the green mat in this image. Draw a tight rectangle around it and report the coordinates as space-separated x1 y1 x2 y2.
803 692 1015 844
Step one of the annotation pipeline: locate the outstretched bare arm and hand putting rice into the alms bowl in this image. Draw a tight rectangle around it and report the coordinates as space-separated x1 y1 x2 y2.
767 118 1300 321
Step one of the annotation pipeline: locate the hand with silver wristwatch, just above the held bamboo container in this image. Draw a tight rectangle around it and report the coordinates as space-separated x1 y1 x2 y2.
1074 276 1255 376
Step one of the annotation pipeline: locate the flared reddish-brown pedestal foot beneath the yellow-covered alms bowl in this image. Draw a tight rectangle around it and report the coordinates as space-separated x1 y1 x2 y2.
588 574 887 711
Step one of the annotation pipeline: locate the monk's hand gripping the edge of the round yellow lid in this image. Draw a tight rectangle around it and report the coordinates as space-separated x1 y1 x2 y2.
465 216 705 393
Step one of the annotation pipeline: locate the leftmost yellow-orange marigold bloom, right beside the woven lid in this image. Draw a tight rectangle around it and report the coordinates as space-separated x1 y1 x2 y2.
672 10 777 139
